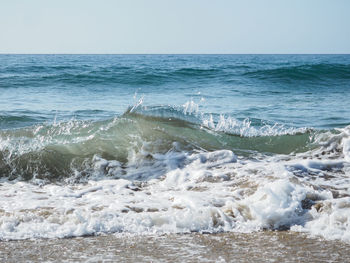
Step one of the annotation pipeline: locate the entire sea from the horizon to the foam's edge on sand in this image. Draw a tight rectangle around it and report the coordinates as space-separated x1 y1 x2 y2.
0 55 350 244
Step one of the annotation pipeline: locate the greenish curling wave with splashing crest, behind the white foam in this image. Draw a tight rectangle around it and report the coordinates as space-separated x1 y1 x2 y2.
0 102 315 181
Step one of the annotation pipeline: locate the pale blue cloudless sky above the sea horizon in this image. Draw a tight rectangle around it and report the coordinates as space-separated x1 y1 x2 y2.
0 0 350 53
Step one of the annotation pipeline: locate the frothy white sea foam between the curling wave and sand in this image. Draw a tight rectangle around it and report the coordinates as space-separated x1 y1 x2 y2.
0 127 350 242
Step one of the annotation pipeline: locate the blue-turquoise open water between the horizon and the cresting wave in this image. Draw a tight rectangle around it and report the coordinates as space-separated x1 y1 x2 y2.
0 55 350 129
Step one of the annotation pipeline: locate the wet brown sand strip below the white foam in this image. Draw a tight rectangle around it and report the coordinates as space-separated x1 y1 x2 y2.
0 231 350 262
